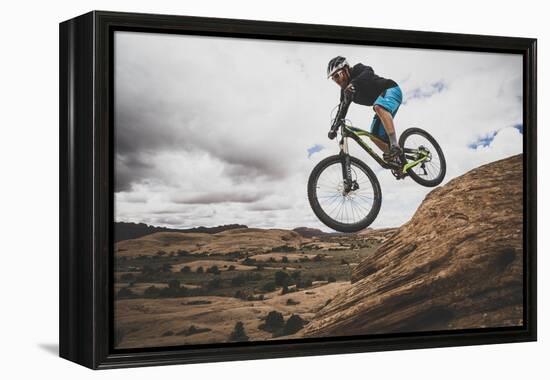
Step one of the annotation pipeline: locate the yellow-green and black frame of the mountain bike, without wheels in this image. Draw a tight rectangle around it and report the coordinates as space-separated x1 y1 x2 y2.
339 124 429 174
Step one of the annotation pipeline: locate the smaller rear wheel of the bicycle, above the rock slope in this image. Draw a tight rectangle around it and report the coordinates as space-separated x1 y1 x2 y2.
399 128 447 187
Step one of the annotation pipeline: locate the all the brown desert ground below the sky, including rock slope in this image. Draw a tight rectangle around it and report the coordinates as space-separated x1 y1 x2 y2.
113 155 523 348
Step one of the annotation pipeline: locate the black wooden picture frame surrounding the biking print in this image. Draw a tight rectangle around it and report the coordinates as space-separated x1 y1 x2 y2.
59 11 537 369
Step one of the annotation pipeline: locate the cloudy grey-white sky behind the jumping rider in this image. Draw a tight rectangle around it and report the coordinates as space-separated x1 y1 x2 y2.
115 32 523 231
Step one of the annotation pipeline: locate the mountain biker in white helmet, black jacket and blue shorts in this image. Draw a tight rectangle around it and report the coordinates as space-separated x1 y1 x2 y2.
327 56 403 165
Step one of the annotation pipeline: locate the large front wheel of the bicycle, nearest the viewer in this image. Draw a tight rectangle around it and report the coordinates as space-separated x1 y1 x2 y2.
307 156 382 232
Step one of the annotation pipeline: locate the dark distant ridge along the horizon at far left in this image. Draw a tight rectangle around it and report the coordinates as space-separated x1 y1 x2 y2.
115 222 248 242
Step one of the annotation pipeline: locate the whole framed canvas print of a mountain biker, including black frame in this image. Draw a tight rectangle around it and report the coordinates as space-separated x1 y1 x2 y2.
60 11 536 369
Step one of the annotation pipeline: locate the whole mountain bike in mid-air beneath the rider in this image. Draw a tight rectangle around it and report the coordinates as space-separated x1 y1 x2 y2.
307 122 447 233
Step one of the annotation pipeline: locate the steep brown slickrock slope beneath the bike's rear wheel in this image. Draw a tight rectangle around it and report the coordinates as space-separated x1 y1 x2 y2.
306 155 523 336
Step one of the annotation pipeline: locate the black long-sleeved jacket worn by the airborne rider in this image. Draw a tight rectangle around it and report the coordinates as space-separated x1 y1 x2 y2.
340 63 397 106
